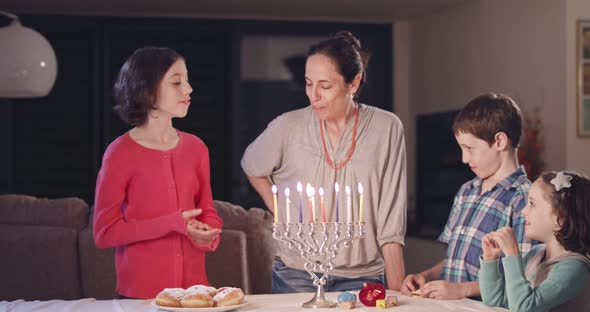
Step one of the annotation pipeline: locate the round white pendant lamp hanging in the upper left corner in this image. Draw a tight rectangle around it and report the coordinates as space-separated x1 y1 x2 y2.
0 11 57 99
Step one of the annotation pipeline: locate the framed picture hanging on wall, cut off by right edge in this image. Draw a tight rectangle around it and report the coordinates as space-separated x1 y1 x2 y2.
576 20 590 137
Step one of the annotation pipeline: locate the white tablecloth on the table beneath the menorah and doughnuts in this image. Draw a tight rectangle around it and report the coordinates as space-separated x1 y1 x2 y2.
0 291 508 312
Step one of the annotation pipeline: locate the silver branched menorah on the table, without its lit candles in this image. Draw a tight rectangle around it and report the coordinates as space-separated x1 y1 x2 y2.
272 222 365 308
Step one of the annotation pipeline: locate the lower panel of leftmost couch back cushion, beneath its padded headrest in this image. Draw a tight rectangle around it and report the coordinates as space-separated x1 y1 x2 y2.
0 224 80 300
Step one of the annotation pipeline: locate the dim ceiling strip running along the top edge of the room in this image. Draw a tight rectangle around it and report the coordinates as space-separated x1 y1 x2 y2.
0 0 468 21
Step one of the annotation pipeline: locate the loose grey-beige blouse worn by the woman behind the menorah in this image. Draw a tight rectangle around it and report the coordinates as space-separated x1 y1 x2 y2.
242 104 407 278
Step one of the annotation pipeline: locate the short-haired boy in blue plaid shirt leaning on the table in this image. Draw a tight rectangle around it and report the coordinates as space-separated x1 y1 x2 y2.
401 93 532 299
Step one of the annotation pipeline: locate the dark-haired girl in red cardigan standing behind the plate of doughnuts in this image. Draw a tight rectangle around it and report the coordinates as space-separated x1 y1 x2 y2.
94 47 222 298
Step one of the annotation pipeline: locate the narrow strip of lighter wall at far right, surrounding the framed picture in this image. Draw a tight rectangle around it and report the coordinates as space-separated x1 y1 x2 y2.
564 0 590 175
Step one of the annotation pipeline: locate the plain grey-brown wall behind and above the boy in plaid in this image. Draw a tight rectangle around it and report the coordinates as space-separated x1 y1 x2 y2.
394 0 568 216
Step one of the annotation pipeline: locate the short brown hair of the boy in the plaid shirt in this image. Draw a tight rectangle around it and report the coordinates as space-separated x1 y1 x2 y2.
453 93 522 148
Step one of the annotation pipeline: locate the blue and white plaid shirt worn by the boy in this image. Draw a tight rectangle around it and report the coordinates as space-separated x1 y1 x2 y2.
438 167 532 283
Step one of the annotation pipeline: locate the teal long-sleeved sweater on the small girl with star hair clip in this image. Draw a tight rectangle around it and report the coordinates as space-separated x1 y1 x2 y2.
479 244 590 312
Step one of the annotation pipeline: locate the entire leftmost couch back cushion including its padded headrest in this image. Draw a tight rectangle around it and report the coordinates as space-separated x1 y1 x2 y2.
0 194 89 300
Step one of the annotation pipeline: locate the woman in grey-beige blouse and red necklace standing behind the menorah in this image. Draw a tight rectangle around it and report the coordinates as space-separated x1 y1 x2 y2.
242 32 406 293
